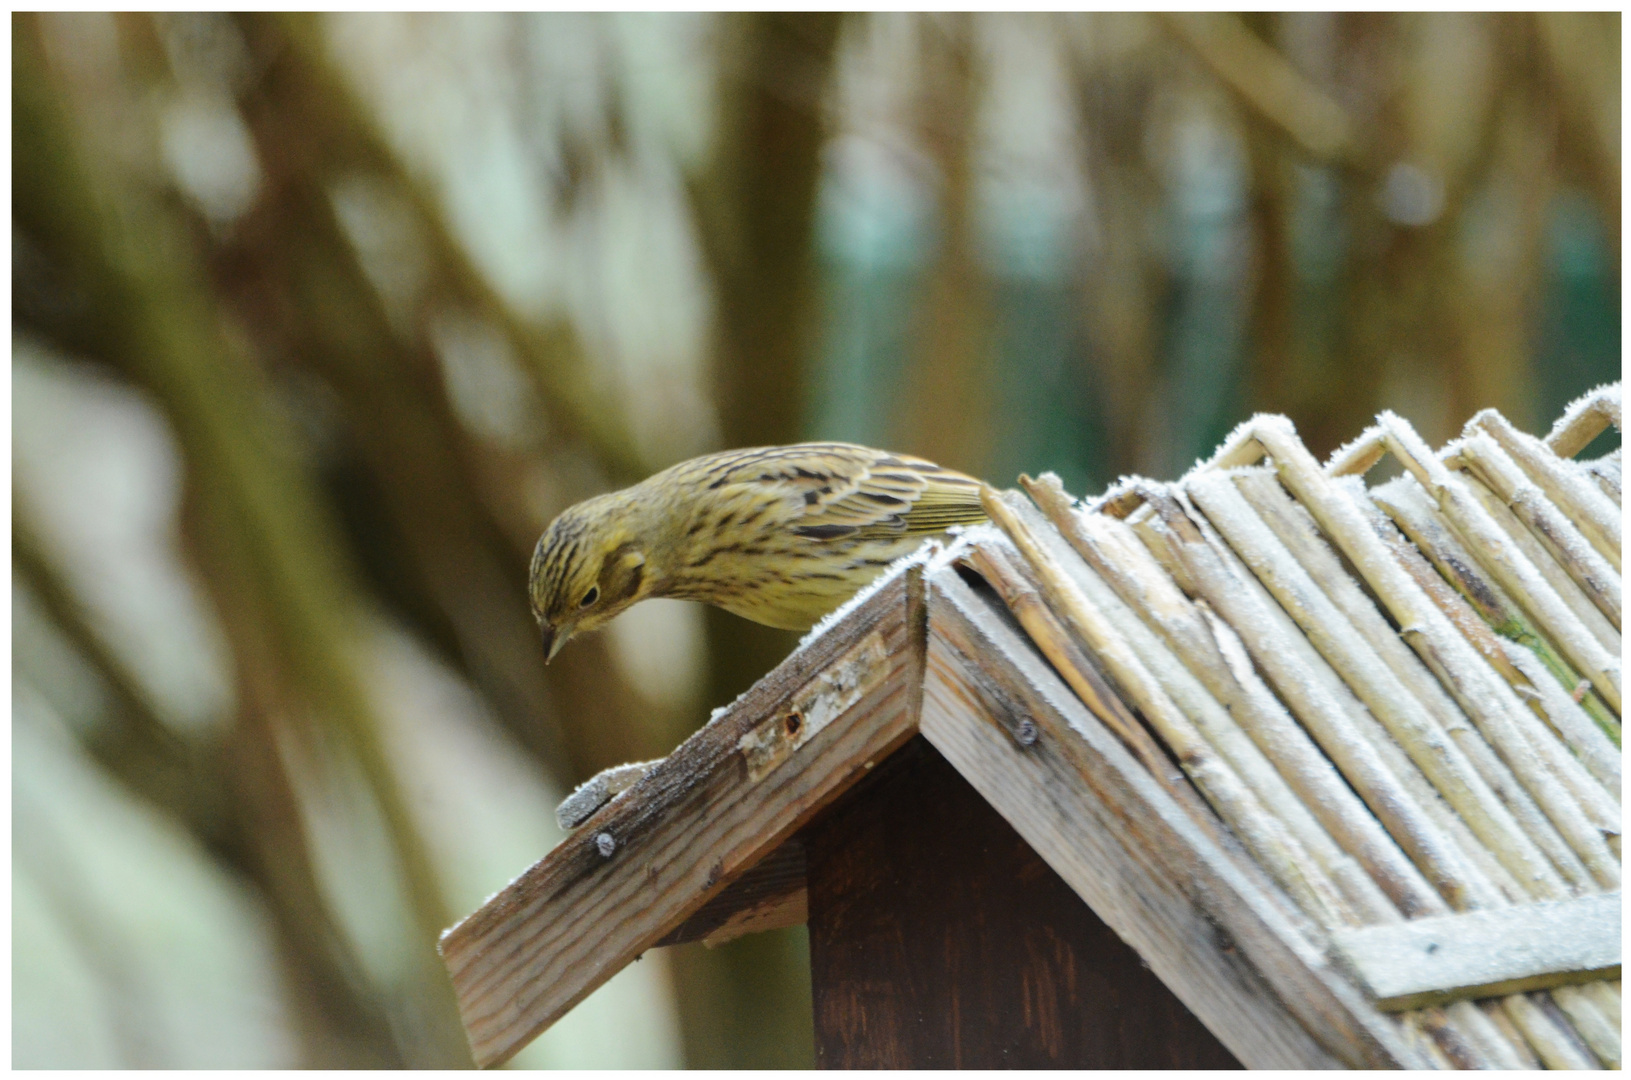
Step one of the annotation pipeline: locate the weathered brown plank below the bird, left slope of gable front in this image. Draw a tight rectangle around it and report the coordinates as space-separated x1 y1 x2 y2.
440 568 922 1065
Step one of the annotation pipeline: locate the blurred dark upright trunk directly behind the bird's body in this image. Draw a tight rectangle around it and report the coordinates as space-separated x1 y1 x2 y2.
674 13 840 1069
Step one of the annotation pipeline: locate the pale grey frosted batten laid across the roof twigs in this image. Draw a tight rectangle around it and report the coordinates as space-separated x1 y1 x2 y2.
1331 892 1620 1010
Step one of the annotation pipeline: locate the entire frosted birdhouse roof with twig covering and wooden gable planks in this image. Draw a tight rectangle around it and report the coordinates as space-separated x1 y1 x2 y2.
442 385 1621 1067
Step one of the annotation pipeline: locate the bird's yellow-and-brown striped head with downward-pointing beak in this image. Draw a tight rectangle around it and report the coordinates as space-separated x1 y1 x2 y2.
528 493 652 659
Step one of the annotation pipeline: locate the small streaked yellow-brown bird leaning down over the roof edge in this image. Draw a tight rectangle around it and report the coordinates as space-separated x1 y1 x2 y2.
530 442 985 659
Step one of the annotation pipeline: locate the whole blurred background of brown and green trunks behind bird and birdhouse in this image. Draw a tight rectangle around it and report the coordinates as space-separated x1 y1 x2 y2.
11 13 1620 1067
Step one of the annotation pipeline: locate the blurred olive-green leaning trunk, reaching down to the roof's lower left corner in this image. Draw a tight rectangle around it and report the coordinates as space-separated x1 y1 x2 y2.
11 18 468 1065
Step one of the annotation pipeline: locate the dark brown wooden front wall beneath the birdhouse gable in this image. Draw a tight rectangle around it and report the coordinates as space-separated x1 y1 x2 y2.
804 736 1240 1069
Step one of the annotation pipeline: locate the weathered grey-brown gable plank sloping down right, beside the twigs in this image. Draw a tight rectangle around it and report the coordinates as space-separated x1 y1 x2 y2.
920 569 1427 1069
